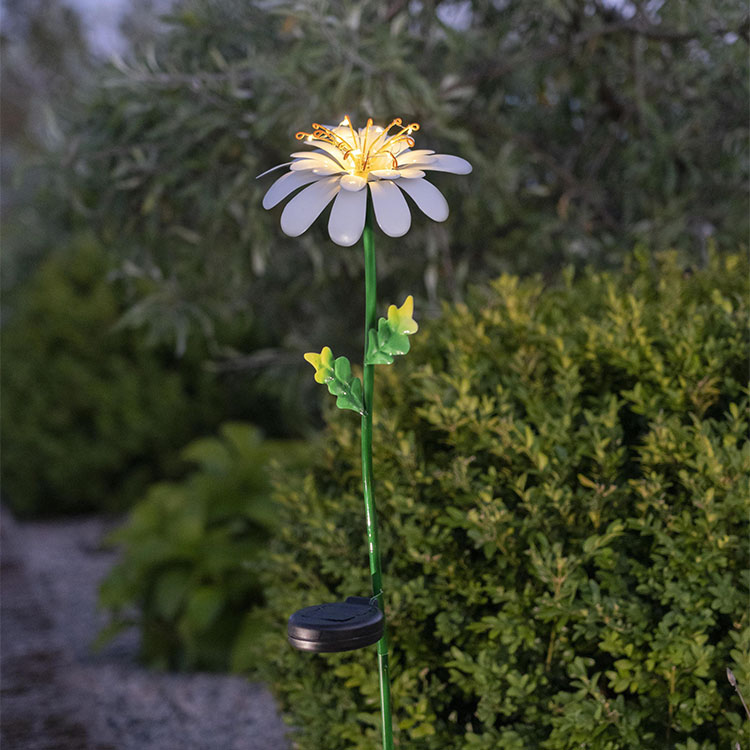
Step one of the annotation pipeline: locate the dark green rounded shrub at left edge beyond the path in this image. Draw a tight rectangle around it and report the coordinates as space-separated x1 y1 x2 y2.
0 239 223 515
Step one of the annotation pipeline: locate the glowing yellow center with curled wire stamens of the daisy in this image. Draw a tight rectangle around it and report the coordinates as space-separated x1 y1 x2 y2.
295 115 419 179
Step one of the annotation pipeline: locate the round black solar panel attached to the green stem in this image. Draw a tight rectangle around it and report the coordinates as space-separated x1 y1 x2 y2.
287 596 384 653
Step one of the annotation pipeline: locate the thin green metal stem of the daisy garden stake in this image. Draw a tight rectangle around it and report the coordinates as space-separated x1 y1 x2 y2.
362 199 393 750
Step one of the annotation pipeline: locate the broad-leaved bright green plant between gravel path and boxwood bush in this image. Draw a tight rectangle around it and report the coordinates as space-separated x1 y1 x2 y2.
100 423 312 669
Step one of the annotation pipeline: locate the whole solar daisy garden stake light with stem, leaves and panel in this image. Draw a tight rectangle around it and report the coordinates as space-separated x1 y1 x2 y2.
260 115 471 750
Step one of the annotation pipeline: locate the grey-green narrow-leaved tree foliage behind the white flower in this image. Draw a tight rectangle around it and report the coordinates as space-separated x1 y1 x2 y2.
55 0 748 350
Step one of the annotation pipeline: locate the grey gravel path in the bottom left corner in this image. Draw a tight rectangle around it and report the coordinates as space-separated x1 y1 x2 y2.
0 511 290 750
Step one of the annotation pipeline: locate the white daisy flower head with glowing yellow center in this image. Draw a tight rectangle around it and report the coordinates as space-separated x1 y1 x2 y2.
259 115 472 247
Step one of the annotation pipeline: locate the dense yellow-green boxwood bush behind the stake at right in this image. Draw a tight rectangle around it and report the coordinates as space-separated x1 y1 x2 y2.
245 252 750 750
